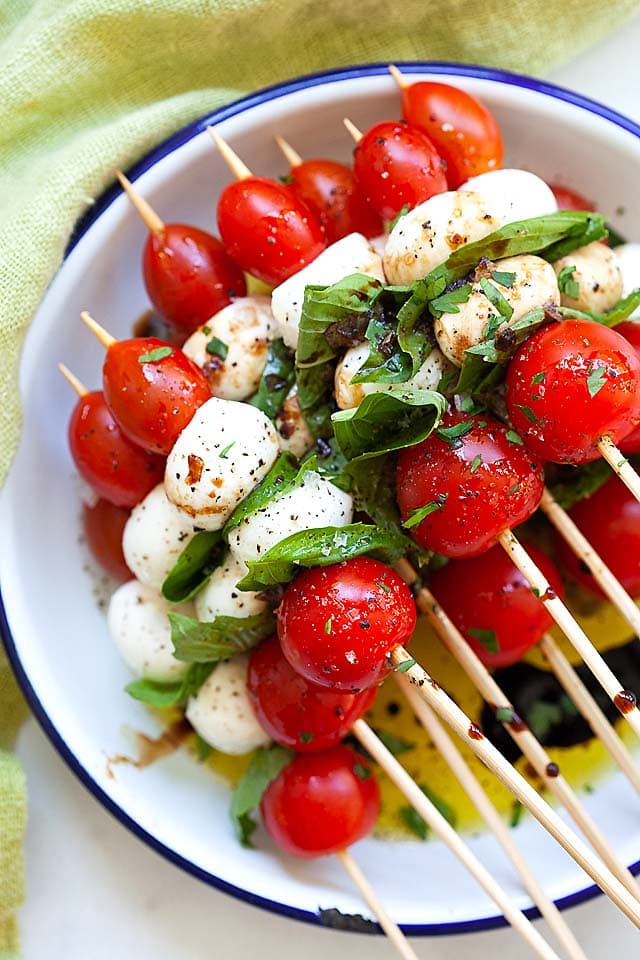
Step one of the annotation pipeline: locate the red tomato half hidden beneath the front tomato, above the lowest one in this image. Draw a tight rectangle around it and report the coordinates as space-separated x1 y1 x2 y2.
247 637 376 753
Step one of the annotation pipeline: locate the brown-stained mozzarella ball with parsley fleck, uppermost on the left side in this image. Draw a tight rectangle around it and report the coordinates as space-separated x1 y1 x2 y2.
182 297 275 400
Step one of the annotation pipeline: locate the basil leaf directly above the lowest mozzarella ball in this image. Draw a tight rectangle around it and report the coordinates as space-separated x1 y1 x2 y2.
167 612 276 663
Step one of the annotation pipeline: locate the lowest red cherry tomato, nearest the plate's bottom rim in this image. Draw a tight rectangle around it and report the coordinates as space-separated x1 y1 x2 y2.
260 746 380 858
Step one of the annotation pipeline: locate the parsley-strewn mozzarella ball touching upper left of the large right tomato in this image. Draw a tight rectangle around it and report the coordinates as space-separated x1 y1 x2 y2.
433 254 559 367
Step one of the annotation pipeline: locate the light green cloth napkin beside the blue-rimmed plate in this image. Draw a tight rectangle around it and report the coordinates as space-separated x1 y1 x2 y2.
0 0 639 960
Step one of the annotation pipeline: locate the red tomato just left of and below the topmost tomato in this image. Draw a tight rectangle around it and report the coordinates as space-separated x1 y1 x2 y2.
353 121 447 220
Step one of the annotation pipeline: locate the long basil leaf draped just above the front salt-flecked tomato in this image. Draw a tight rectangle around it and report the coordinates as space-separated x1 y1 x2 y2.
238 523 405 590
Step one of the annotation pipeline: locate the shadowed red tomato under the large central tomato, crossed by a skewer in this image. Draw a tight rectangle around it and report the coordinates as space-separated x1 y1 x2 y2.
431 544 564 668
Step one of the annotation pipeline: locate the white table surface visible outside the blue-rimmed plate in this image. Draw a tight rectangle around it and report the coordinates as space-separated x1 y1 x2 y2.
12 18 640 960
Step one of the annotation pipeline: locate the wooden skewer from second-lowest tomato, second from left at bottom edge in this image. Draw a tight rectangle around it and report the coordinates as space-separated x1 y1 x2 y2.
352 720 564 960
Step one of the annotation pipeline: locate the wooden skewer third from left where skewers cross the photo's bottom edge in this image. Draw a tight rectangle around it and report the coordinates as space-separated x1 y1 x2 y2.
394 673 586 960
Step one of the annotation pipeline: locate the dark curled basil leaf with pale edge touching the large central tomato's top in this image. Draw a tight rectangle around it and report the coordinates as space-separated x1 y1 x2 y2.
331 387 446 460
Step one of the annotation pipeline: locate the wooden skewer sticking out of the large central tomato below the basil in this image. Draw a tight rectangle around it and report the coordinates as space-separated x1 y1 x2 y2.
498 530 640 736
